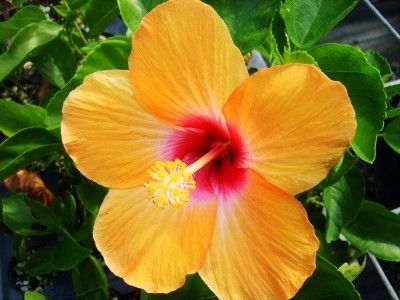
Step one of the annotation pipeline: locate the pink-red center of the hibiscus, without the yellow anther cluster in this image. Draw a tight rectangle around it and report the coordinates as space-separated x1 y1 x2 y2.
166 116 246 201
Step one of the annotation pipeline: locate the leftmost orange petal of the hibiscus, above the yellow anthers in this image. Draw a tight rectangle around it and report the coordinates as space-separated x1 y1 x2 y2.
61 70 167 188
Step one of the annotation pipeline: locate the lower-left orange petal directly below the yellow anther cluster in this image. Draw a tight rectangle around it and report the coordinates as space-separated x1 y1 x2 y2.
93 187 216 293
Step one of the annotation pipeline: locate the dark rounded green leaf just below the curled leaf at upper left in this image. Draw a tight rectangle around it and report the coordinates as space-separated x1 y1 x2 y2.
34 38 76 88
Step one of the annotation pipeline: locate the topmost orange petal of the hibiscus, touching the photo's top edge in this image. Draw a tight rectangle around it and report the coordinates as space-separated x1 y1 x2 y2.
129 0 248 123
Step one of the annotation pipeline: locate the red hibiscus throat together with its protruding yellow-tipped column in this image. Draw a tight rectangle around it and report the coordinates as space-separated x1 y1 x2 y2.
146 116 246 207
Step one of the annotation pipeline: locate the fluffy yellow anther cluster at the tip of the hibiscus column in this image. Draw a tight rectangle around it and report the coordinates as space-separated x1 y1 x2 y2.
145 159 196 208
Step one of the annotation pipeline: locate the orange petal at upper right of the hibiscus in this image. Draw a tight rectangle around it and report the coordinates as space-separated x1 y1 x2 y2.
223 64 356 194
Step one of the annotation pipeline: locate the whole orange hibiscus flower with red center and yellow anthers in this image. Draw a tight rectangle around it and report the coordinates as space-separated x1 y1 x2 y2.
61 0 356 299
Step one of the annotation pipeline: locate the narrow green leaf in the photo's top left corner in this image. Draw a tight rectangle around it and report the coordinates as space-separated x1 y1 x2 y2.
0 5 46 44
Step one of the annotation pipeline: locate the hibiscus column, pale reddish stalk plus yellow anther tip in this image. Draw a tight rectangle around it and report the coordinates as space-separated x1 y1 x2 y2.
144 142 229 208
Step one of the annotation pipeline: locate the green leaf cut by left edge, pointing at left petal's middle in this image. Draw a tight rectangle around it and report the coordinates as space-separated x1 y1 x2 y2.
0 100 46 136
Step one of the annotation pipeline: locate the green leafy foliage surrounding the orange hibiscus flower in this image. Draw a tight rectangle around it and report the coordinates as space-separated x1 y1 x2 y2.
0 0 400 300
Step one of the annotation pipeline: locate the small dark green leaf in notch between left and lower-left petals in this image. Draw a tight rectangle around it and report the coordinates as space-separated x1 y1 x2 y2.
76 182 108 215
